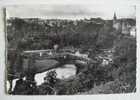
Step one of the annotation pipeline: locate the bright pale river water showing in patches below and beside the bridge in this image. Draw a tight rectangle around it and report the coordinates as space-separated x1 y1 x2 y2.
7 48 112 92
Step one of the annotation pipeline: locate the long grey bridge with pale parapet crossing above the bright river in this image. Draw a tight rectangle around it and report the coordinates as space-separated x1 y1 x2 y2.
23 50 96 73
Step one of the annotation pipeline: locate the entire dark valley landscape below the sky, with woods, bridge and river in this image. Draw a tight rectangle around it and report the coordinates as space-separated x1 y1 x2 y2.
6 13 136 95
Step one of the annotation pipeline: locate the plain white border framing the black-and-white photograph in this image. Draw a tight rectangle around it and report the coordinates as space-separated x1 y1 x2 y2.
0 0 140 100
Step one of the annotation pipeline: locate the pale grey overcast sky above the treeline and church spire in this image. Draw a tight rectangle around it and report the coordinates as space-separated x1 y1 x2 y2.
7 5 135 19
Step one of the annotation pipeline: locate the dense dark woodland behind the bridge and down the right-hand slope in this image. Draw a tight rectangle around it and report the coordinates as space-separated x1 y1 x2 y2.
7 18 136 94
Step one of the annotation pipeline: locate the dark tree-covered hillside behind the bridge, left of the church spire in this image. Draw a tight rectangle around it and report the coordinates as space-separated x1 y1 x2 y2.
7 18 103 50
